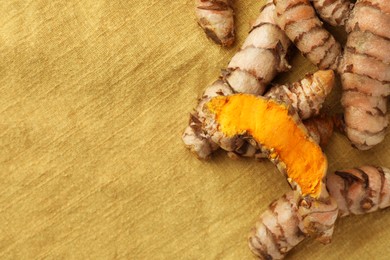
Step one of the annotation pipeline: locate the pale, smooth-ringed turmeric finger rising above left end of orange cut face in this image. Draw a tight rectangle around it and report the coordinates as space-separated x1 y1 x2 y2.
222 0 291 95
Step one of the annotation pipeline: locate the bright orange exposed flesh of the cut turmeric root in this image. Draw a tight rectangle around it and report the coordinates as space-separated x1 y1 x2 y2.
207 94 327 197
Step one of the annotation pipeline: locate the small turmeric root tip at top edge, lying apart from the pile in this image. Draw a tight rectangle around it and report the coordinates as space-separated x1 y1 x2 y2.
195 0 234 46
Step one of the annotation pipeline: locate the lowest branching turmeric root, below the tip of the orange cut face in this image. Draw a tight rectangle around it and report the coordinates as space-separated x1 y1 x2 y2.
249 166 390 259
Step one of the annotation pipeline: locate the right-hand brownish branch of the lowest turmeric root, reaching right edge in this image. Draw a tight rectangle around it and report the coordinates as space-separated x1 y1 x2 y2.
326 166 390 217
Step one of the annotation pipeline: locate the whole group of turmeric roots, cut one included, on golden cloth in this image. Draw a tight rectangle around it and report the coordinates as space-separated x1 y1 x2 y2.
182 0 390 259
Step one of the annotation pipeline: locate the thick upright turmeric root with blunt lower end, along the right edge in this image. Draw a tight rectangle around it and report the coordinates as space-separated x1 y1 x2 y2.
340 0 390 150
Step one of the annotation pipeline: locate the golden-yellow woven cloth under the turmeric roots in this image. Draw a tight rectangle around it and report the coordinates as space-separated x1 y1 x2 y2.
0 0 390 259
